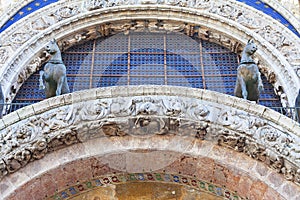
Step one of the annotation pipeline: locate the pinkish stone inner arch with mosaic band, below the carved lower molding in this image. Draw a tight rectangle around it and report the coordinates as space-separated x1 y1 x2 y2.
7 135 299 199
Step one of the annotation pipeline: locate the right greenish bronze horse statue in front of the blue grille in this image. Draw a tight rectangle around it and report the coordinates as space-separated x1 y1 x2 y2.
234 39 264 102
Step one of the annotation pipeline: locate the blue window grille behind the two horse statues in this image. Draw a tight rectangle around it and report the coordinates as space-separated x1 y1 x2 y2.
14 31 281 107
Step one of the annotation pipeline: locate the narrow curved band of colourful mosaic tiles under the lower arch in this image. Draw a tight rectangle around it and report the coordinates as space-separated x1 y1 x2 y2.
49 173 244 200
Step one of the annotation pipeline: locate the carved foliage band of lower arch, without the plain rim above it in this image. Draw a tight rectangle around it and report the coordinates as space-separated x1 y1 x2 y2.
0 88 300 183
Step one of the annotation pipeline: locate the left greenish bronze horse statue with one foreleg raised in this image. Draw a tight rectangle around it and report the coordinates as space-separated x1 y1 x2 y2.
40 39 70 98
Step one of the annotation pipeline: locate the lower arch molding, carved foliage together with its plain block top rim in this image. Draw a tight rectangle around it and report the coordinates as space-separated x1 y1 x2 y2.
0 86 300 184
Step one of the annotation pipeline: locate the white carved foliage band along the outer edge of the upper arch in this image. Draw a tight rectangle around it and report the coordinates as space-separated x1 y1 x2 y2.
0 0 300 68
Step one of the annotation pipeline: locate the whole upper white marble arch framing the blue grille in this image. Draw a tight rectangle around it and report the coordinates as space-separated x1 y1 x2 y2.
0 0 300 106
